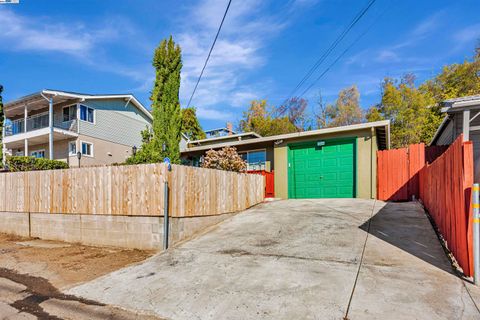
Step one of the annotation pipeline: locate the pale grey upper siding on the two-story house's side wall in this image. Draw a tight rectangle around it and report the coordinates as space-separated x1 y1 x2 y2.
79 99 151 146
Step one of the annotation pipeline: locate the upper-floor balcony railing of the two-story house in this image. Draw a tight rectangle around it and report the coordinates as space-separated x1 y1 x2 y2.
5 112 77 136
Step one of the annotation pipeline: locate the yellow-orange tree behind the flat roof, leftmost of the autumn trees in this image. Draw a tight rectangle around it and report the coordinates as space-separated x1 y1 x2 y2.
239 100 298 136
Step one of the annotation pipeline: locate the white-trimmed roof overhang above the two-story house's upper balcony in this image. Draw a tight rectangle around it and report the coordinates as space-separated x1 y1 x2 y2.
4 89 153 120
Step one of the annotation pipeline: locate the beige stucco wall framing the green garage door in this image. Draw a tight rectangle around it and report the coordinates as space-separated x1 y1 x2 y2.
274 129 377 199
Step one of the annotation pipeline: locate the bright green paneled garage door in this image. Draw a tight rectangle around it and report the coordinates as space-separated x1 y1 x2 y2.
288 139 356 198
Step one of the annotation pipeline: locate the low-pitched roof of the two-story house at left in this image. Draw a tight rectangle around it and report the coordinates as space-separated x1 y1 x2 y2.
4 89 153 120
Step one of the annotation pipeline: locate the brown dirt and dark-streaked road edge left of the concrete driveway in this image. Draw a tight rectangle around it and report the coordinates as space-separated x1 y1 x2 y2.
0 233 157 320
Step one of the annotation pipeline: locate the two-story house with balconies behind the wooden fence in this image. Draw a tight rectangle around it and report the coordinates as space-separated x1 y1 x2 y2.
2 90 152 167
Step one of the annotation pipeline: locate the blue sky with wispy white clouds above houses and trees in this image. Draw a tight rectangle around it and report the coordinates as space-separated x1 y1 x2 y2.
0 0 480 129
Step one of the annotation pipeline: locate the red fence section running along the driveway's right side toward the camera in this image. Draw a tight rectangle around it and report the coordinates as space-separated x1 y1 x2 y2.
419 136 474 276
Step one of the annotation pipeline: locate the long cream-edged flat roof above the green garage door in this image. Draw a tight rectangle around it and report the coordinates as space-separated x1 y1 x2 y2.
182 120 390 153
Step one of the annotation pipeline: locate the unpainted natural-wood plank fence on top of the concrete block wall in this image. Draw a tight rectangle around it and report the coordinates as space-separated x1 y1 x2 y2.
0 164 264 217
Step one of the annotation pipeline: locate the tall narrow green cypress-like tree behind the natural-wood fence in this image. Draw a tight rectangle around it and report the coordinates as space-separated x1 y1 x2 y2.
127 36 182 164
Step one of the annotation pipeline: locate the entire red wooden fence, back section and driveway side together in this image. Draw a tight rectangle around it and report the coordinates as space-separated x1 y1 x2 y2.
377 136 473 276
